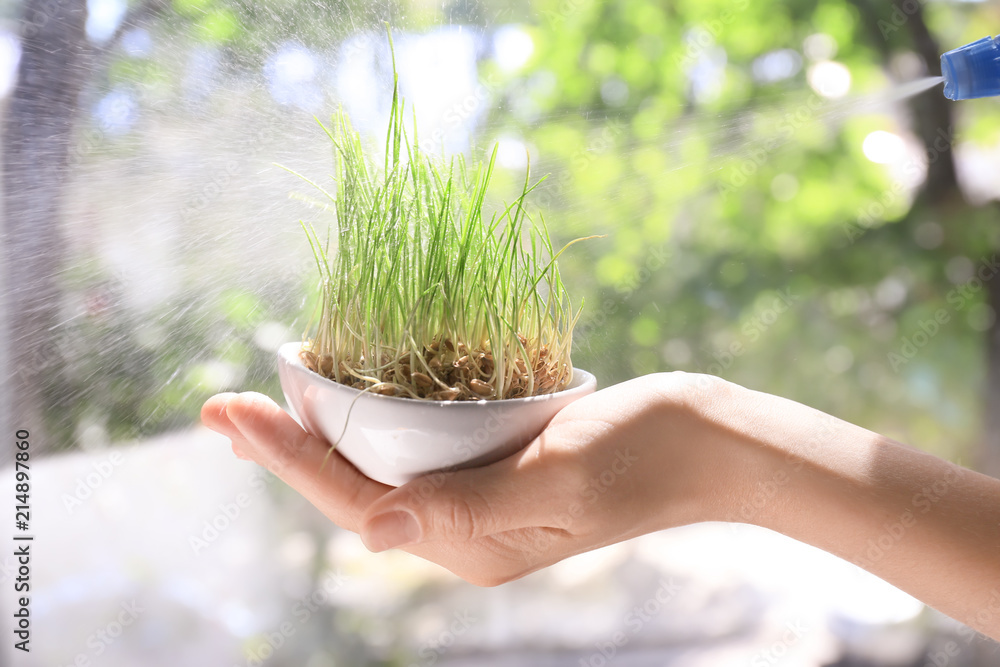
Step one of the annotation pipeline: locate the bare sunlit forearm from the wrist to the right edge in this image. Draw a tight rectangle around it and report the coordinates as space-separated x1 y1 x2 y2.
692 385 1000 639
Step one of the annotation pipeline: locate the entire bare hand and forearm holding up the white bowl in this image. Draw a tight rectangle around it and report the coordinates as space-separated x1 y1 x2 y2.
202 373 1000 639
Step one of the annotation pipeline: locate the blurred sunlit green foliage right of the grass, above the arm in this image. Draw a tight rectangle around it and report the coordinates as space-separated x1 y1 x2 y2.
476 0 1000 461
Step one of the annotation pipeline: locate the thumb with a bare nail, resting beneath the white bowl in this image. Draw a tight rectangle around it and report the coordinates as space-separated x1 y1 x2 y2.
361 450 566 551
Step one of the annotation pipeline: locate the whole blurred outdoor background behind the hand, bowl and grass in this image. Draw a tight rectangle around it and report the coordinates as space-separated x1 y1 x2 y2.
0 0 1000 667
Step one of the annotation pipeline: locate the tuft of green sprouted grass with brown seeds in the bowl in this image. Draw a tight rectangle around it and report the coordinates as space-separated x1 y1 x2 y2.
290 30 591 401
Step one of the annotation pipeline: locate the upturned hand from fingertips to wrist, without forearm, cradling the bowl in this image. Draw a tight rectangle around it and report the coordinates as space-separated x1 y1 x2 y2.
202 373 746 585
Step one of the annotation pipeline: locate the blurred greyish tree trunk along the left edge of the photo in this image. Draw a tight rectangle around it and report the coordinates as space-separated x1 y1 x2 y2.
3 0 90 452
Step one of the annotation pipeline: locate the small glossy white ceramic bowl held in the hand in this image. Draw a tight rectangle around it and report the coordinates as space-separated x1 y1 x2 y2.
278 343 597 486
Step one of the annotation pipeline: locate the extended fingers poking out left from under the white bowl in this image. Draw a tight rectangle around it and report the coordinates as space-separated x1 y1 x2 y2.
202 392 392 532
